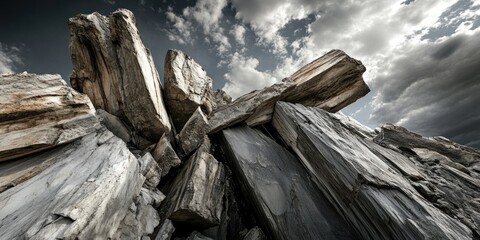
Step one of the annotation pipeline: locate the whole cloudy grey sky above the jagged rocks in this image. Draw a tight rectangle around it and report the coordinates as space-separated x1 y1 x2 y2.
0 0 480 147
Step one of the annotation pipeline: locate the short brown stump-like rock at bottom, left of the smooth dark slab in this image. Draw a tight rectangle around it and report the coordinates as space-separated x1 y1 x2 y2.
161 151 225 227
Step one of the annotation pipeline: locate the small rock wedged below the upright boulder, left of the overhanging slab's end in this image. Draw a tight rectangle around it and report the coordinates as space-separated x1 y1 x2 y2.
178 107 209 156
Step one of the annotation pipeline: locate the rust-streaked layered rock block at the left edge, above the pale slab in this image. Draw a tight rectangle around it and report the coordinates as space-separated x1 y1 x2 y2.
0 74 98 161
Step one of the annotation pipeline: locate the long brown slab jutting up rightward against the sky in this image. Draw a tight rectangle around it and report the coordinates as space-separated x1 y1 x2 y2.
209 50 370 133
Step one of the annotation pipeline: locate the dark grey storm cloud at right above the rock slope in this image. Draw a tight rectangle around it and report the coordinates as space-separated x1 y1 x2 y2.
372 31 480 147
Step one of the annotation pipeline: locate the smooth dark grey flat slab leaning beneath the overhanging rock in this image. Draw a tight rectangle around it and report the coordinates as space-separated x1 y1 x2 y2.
222 127 355 239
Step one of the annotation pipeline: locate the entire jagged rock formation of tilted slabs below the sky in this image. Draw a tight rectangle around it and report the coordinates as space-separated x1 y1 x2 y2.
0 9 480 240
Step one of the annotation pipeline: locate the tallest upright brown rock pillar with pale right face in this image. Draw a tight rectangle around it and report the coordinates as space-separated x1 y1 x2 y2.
69 9 171 142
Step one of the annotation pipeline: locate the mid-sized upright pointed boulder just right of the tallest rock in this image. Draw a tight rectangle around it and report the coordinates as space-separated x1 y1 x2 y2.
164 49 215 131
